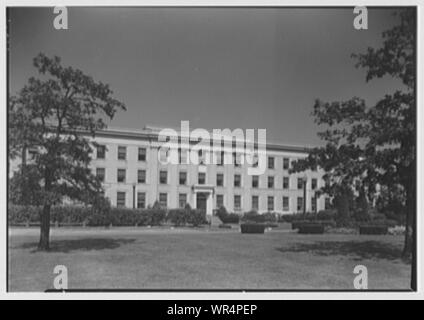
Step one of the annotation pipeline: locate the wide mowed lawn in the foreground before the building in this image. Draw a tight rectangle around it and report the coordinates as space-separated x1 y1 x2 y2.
8 228 410 291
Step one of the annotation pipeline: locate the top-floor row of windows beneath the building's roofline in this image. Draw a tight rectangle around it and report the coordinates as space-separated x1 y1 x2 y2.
97 145 306 170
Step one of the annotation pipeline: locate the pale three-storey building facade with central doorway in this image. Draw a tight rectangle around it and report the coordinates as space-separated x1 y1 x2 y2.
83 128 328 215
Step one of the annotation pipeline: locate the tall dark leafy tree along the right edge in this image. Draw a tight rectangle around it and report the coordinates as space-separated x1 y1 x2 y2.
295 8 416 258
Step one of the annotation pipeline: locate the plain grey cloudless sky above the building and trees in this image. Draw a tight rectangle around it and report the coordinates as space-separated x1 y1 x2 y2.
8 7 400 146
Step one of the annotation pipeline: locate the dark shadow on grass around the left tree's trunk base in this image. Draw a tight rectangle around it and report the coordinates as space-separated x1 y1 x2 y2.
18 238 135 253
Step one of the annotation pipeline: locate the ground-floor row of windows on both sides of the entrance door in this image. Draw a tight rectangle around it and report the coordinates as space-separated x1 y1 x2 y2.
116 191 330 212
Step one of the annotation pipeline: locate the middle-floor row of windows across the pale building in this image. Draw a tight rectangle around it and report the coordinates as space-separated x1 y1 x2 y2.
96 168 318 190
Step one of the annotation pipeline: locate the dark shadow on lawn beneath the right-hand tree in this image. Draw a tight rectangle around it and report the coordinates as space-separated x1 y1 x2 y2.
277 240 408 261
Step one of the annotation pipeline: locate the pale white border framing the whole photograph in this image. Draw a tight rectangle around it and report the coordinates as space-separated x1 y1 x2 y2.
0 0 424 300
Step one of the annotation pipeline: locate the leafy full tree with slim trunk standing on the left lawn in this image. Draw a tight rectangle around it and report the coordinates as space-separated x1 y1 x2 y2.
9 53 125 250
